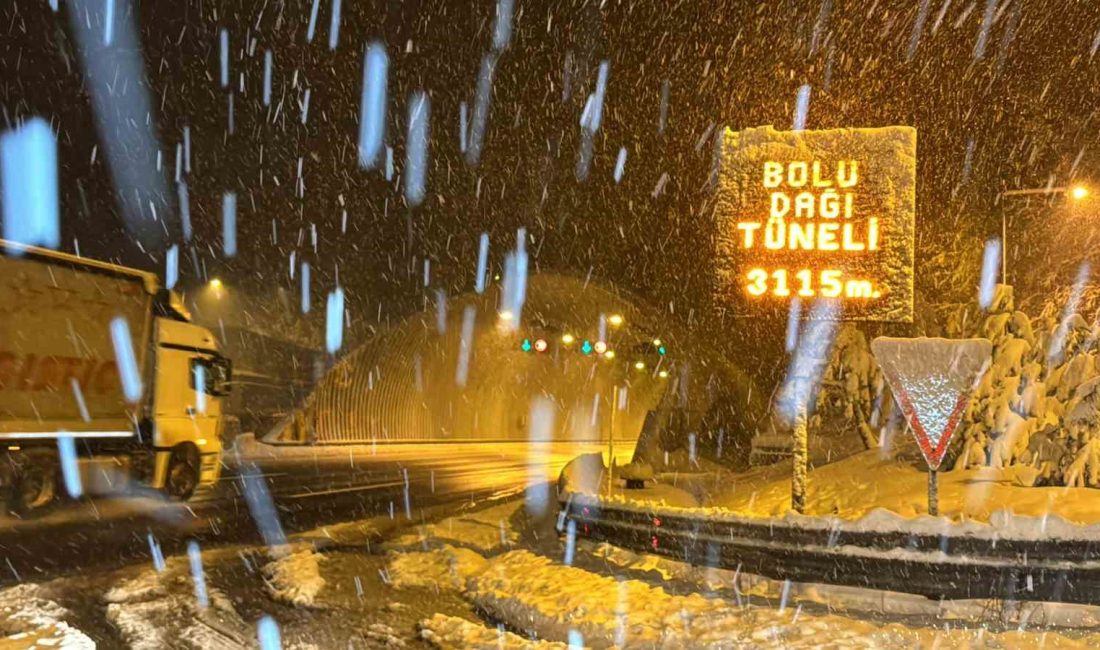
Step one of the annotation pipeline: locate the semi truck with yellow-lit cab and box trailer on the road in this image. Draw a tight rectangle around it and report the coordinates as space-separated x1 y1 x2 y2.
0 240 232 514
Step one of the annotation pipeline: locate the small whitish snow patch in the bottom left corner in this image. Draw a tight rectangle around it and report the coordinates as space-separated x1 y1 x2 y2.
0 584 96 650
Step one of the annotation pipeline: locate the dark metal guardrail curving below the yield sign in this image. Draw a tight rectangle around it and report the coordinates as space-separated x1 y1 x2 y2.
561 494 1100 605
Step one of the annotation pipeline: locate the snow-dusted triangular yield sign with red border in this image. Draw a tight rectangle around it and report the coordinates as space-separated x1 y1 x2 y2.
871 337 993 470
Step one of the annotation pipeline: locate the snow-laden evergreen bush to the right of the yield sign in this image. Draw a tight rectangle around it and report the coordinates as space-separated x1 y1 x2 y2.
947 285 1100 487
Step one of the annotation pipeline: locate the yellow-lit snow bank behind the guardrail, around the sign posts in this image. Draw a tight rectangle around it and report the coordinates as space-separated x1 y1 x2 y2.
574 450 1100 541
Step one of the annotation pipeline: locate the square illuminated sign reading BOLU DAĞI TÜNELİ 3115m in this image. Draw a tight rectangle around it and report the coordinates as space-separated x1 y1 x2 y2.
717 126 916 321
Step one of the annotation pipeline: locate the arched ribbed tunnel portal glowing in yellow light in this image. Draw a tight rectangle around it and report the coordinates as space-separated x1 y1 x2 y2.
270 274 759 466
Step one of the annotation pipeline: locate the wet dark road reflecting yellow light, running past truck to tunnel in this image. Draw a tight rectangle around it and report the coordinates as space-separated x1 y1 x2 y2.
0 436 633 584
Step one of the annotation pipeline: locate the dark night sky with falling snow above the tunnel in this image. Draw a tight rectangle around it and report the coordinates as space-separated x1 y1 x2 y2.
0 0 1100 345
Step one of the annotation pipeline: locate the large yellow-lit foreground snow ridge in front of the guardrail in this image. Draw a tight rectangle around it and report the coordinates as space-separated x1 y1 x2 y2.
466 551 1100 648
